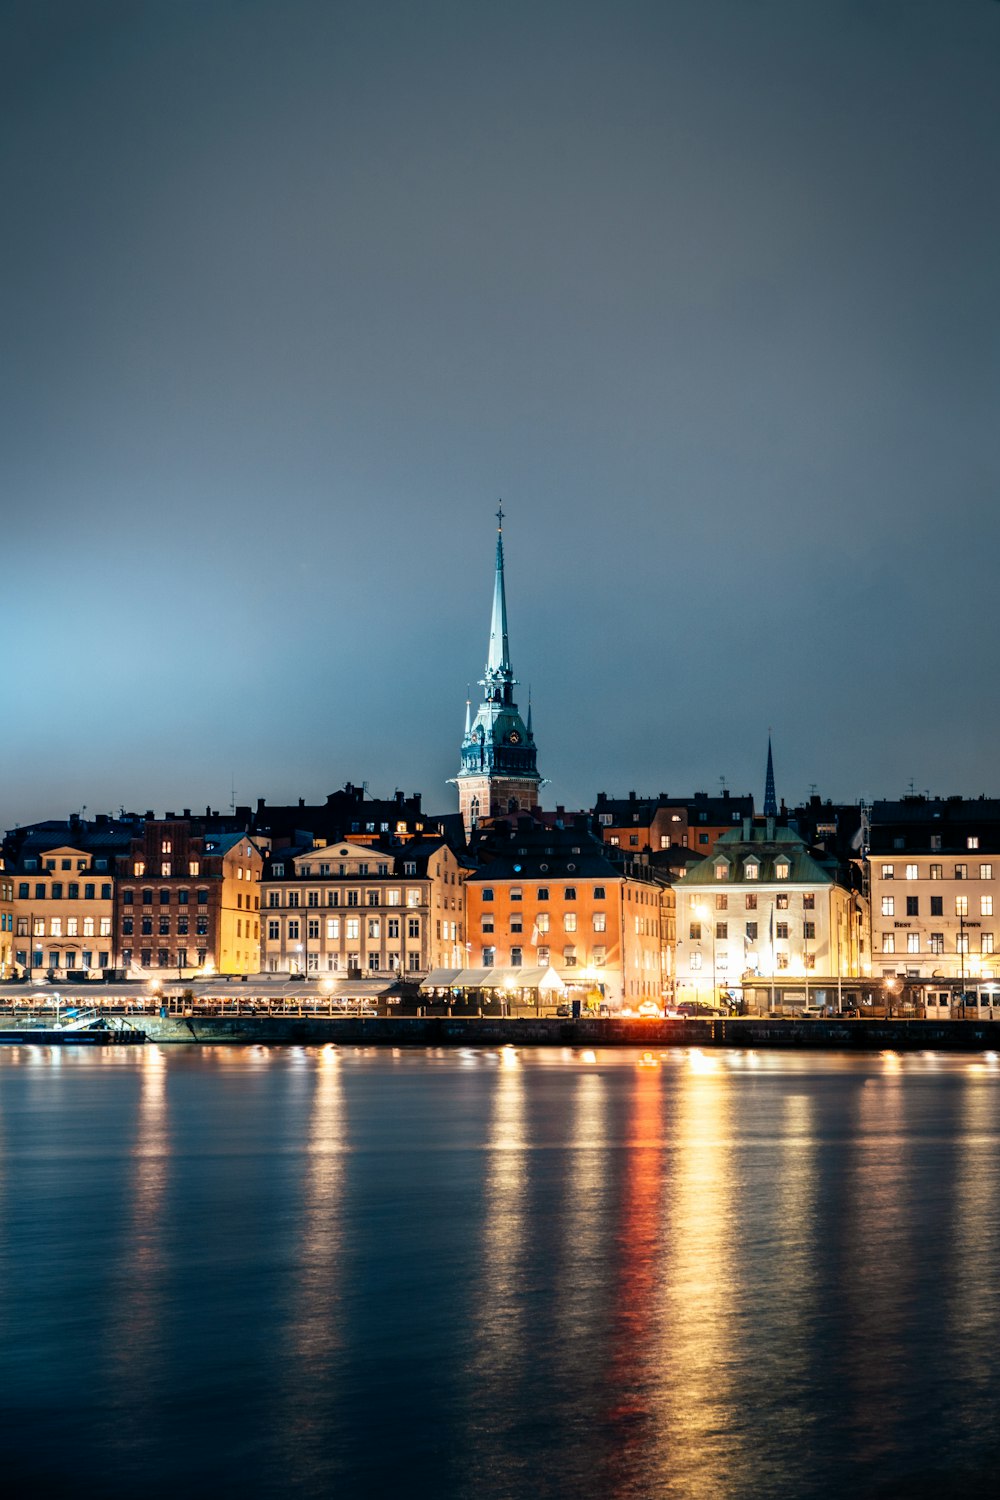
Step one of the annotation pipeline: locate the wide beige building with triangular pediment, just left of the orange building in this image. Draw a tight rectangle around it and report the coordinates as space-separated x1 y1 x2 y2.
261 839 465 978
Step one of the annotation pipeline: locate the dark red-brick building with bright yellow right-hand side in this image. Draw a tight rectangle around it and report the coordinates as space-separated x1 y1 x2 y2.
114 812 264 978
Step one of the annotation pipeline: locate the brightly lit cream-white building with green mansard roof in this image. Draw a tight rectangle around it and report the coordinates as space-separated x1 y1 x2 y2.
675 818 870 1011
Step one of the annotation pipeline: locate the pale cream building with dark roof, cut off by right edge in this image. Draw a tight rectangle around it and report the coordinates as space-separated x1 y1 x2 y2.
867 795 1000 1019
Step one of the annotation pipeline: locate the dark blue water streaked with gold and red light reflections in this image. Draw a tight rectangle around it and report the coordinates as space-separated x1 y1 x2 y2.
0 1047 1000 1500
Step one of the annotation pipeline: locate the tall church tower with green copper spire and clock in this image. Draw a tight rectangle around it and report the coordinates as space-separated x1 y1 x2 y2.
453 507 541 837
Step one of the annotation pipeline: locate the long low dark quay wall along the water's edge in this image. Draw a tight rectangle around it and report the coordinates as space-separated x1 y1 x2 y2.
135 1016 1000 1052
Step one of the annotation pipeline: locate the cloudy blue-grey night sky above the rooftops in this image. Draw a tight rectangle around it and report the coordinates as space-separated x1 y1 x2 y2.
0 0 1000 827
